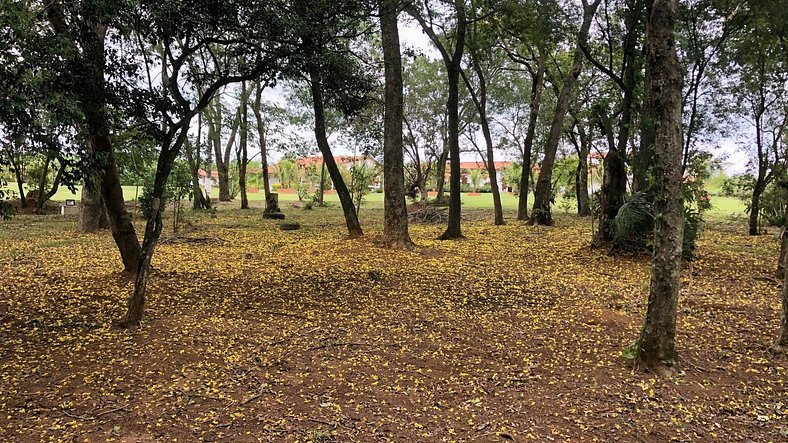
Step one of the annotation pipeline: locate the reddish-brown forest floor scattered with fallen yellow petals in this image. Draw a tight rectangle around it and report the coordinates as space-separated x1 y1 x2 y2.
0 205 788 442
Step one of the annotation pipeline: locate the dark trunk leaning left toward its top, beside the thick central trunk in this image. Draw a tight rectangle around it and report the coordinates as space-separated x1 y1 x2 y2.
309 71 364 238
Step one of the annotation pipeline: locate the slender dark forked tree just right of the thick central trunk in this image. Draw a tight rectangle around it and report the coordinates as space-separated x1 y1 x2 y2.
407 0 467 240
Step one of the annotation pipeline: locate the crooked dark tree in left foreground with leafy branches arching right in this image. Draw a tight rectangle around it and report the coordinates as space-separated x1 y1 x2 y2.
119 2 286 326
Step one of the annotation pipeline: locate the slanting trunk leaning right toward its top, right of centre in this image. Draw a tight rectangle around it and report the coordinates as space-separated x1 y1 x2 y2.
531 0 601 225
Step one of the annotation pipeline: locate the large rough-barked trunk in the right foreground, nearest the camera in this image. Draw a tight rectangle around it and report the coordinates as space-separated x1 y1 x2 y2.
636 0 684 366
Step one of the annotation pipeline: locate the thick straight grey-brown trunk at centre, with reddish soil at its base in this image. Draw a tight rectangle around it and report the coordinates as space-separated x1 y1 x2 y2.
380 0 413 249
